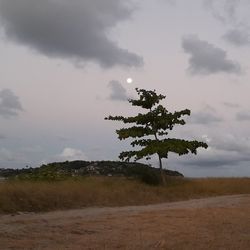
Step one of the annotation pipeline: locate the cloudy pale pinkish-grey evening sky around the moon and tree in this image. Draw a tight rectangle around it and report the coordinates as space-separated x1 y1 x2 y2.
0 0 250 177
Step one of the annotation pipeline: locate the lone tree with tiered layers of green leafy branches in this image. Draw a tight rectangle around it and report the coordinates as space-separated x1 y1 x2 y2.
105 88 208 183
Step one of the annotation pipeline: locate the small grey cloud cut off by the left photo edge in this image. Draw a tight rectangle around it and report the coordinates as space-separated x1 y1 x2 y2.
0 89 23 118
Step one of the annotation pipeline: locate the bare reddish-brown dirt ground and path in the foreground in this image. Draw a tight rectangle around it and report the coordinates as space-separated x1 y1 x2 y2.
0 195 250 250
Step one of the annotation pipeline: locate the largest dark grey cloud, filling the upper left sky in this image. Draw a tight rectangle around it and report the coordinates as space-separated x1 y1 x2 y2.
0 0 143 68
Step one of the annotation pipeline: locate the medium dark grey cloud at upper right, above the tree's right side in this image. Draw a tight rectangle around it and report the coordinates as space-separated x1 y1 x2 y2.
182 36 241 75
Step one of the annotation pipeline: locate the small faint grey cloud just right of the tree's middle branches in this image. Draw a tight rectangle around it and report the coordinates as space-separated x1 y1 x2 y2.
189 106 223 125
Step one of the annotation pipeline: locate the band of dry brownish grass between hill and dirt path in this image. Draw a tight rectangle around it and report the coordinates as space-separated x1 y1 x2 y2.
0 177 250 214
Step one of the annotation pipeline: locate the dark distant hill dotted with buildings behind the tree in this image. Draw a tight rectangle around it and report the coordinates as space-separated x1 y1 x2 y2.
0 161 183 183
